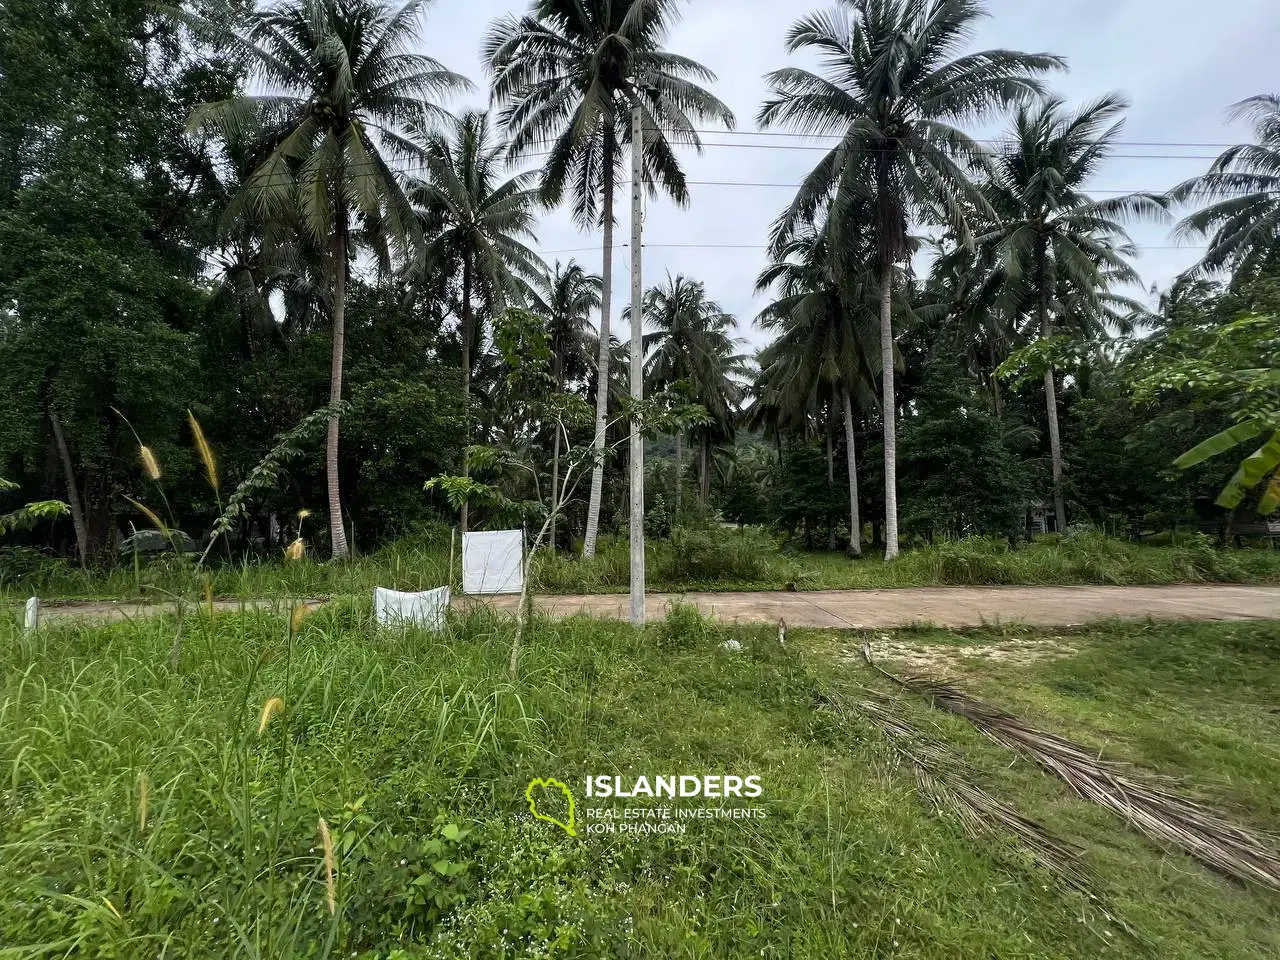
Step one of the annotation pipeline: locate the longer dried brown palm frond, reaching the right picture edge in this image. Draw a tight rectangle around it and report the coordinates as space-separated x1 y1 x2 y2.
863 644 1280 890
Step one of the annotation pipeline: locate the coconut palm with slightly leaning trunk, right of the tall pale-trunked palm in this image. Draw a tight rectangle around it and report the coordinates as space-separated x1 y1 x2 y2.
978 95 1164 530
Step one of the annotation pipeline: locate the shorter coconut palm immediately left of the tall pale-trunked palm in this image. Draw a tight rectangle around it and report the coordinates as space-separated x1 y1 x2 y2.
755 228 881 557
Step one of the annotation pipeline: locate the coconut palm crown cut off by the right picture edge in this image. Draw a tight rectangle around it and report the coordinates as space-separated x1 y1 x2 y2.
1169 93 1280 276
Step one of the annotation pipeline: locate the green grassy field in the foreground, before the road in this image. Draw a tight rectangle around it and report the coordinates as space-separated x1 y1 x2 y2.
0 598 1280 960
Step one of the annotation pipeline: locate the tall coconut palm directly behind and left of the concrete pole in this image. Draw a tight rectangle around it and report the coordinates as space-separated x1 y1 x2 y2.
484 0 733 557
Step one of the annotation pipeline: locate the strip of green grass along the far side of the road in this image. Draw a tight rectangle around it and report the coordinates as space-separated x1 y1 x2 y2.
0 527 1280 603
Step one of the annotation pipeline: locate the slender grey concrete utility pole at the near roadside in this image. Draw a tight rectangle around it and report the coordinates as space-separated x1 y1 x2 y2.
631 91 645 628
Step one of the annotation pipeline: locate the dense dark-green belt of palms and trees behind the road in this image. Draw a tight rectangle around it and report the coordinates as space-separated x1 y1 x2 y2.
0 0 1280 584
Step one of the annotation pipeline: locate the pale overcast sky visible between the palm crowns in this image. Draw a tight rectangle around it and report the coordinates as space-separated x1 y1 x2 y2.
414 0 1280 346
